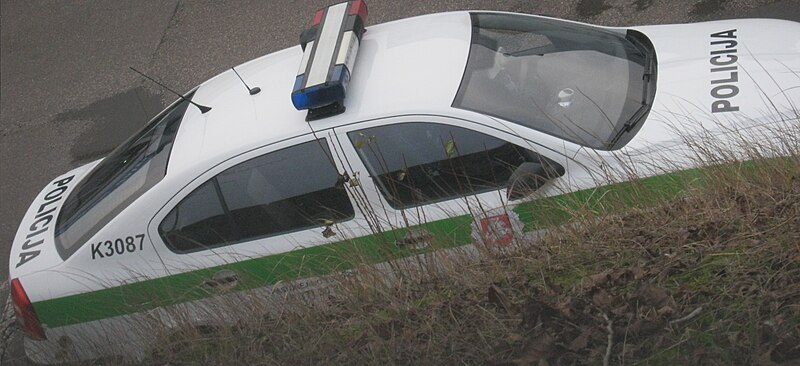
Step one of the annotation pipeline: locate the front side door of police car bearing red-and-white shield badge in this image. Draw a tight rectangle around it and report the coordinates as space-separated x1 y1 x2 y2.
336 115 568 251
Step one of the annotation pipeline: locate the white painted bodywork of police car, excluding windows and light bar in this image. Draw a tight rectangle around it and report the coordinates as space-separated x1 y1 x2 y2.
9 12 800 363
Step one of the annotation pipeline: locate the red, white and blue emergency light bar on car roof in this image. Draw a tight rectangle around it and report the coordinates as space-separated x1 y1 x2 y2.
292 0 367 121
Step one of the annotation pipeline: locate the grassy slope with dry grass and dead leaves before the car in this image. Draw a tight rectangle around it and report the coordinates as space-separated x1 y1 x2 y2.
145 156 800 365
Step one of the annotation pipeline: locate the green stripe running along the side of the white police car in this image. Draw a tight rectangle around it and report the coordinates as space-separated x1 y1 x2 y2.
33 170 702 328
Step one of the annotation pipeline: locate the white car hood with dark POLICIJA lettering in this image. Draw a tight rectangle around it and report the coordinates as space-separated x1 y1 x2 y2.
626 19 800 153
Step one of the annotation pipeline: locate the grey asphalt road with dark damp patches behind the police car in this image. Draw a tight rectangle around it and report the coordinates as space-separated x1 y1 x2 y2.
0 0 800 364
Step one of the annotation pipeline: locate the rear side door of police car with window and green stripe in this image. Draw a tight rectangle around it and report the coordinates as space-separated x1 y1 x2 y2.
148 132 368 314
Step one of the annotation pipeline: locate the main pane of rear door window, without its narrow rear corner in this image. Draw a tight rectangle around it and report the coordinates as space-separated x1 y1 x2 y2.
218 140 354 238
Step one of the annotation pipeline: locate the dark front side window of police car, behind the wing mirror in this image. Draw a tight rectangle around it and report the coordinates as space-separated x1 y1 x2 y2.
348 123 539 209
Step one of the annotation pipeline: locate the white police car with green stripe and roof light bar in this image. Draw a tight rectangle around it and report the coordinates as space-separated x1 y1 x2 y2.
9 1 800 363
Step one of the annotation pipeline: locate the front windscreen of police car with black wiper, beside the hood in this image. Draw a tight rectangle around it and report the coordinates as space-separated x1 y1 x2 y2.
453 13 655 149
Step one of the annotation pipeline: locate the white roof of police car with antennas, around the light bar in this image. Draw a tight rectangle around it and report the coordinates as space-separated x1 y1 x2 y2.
168 12 471 177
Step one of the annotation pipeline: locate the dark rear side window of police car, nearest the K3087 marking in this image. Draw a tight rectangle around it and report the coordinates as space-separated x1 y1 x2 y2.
159 139 355 252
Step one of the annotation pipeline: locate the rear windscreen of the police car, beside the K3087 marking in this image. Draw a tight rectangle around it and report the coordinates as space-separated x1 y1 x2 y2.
55 94 192 259
